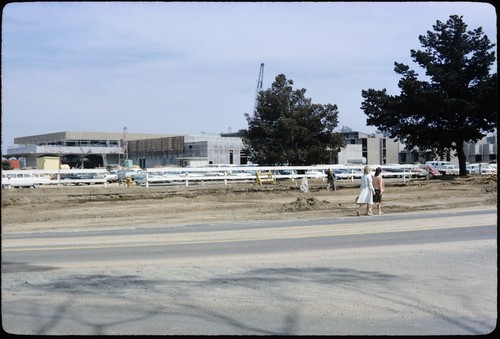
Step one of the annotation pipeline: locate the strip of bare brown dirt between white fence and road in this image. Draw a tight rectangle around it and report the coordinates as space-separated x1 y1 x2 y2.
1 176 497 233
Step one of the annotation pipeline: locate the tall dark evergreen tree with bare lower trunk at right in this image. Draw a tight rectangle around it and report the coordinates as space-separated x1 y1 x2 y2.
361 15 497 175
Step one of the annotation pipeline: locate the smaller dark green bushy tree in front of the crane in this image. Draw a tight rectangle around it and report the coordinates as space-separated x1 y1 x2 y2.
240 74 345 166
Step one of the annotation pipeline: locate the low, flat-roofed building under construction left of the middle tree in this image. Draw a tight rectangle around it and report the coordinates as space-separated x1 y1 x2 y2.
3 130 247 168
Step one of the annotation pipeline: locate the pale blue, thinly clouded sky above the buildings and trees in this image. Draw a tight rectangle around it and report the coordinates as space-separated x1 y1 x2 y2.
1 2 497 150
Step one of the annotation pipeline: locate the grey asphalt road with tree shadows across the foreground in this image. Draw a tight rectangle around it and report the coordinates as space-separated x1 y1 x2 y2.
2 208 497 335
